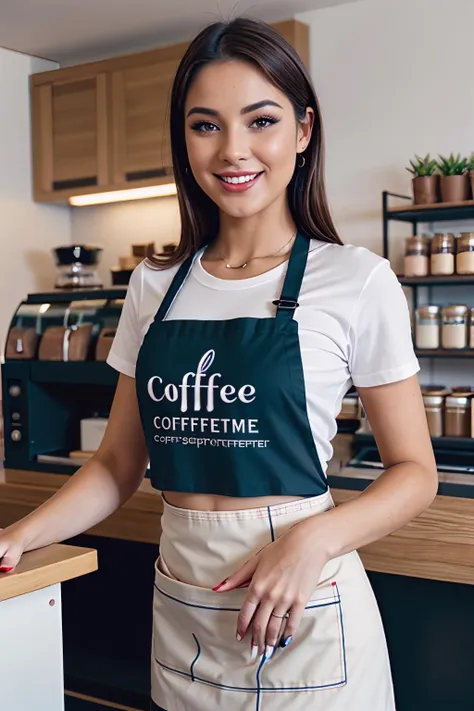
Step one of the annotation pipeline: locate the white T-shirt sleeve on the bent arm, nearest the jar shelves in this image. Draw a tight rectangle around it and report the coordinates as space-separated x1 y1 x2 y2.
349 260 420 387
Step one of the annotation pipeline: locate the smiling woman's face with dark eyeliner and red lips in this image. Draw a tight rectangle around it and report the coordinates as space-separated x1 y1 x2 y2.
185 60 313 217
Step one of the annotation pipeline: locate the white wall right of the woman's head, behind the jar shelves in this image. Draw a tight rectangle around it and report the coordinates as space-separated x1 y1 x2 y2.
298 0 474 385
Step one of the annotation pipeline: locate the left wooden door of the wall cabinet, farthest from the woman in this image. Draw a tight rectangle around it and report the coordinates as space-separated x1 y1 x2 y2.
32 71 110 202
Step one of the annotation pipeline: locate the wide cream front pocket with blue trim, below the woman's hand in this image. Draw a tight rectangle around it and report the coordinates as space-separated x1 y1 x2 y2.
153 564 347 692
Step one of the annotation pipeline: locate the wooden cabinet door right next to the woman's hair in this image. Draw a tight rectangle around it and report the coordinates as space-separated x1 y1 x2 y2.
111 58 179 187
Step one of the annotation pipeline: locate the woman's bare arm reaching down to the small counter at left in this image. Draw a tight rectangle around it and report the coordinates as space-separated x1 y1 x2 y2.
0 375 148 566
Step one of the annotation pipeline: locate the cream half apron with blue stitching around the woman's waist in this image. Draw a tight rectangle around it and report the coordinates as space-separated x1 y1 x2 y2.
152 492 395 711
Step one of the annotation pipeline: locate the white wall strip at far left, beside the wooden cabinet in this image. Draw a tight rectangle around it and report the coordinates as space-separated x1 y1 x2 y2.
0 48 71 352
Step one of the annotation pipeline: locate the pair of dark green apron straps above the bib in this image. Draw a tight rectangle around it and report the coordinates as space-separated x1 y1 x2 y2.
155 232 309 321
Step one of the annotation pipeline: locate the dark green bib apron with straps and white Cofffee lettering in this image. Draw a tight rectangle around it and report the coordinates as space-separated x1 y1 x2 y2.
136 234 327 497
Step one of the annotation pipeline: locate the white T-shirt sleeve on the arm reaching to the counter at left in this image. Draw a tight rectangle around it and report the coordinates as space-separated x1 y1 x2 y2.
107 265 142 378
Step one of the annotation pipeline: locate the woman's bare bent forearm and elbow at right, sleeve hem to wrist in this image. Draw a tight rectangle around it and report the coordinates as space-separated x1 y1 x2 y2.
314 376 438 559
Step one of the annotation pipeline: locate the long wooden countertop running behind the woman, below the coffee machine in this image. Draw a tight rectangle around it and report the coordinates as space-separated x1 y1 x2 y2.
0 458 474 585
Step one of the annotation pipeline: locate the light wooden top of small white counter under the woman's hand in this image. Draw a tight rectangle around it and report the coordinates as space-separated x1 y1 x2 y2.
0 544 98 601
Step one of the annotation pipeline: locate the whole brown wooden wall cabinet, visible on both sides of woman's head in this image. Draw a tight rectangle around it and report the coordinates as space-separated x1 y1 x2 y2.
31 20 309 202
